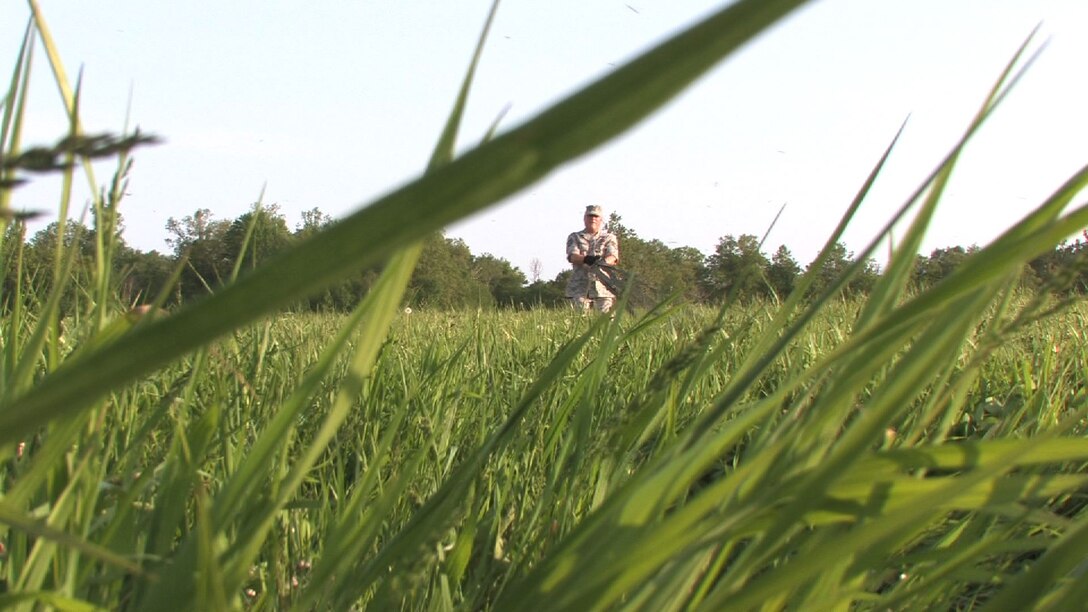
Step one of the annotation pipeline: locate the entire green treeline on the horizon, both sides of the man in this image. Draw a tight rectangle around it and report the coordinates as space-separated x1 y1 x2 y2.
0 206 1088 311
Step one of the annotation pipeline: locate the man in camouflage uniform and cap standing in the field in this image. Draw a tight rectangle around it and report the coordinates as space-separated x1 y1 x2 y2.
567 206 619 313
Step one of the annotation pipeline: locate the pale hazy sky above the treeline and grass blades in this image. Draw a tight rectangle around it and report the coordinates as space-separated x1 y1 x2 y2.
0 0 1088 279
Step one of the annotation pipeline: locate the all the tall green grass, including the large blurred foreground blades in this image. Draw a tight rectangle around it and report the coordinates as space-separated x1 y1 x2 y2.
0 0 1088 610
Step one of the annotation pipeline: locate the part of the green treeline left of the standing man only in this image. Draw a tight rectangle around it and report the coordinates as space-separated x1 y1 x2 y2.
0 206 552 311
